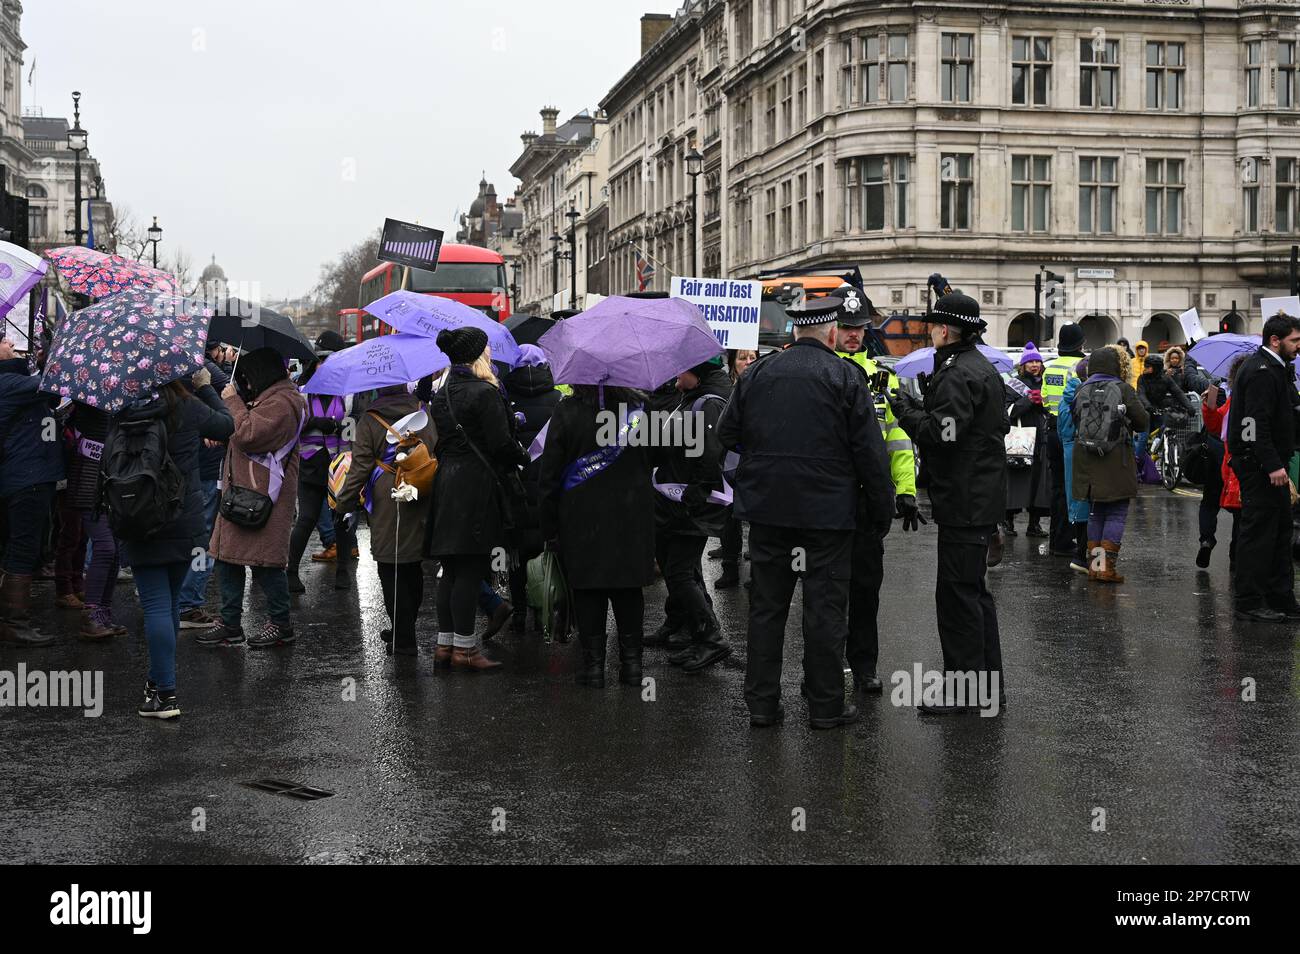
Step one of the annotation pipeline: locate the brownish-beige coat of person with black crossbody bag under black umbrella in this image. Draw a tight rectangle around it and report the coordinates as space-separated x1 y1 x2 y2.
208 378 307 567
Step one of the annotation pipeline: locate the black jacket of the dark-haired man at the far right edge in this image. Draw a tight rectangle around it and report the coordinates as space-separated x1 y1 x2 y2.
1227 347 1300 473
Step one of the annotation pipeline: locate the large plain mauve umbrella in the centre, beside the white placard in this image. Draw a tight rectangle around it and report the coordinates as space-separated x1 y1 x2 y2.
538 295 722 390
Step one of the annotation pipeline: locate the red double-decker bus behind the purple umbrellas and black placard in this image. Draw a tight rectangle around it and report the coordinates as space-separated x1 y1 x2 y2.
339 244 510 342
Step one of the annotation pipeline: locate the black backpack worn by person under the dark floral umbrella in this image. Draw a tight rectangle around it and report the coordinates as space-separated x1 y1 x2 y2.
100 417 185 542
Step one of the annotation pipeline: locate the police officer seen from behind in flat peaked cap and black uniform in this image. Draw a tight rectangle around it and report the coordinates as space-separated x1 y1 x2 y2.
718 298 894 729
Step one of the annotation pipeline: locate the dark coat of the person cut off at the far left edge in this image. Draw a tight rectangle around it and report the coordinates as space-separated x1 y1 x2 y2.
0 357 64 496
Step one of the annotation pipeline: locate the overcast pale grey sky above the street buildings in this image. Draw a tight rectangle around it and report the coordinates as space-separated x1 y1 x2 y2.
22 0 675 299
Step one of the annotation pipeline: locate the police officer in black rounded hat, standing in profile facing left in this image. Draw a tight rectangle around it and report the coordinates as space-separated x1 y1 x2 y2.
891 292 1009 715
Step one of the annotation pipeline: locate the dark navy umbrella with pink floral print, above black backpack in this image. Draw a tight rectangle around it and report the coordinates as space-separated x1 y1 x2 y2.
40 289 212 415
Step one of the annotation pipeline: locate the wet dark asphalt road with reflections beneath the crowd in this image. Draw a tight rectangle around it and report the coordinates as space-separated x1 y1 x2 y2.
0 491 1300 863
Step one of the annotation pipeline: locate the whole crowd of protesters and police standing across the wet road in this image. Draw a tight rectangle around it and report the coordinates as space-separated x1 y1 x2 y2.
0 287 1300 728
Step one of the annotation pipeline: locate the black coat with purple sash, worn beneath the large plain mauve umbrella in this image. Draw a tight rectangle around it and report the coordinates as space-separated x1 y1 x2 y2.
540 396 658 590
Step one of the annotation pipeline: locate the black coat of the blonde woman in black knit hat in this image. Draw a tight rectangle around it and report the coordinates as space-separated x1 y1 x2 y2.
424 365 528 558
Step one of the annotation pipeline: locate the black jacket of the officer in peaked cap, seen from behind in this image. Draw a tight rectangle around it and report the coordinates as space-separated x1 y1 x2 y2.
718 338 894 530
